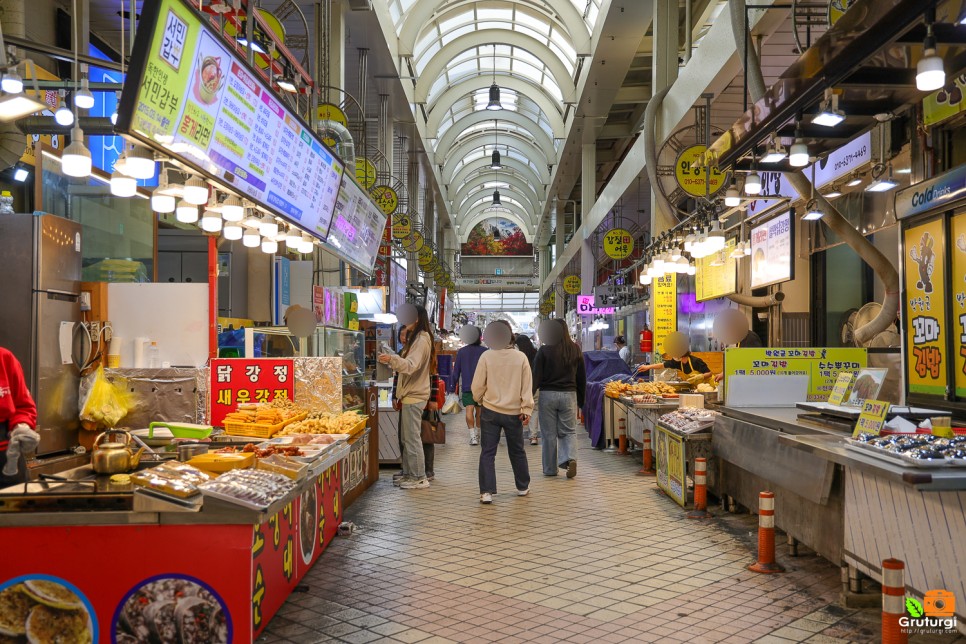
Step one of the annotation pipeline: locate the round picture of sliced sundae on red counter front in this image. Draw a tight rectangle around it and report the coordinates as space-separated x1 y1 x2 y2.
112 575 232 644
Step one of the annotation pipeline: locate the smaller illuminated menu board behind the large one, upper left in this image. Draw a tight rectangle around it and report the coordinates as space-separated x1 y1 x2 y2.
326 177 386 273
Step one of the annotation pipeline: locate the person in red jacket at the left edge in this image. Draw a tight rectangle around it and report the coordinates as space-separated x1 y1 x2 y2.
0 347 40 486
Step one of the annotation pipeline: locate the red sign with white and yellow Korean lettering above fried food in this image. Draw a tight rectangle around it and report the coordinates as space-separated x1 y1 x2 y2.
208 358 295 426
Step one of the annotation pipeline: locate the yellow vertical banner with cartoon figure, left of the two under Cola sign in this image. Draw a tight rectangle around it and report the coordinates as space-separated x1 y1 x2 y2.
902 219 949 396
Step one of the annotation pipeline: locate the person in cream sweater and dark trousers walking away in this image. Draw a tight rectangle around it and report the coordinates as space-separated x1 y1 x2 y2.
472 320 533 503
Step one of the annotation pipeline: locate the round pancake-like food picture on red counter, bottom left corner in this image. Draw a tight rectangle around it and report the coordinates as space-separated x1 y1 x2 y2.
0 579 94 644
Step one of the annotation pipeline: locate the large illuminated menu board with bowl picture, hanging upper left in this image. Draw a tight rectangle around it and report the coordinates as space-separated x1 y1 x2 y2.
117 0 344 239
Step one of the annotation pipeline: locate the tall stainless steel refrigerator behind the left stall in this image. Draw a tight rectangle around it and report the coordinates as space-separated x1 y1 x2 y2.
0 214 85 455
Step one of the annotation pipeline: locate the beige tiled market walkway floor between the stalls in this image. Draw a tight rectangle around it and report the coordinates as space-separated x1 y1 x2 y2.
259 417 966 644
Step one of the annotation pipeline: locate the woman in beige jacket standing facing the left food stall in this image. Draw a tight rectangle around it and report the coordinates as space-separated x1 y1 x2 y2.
378 303 436 490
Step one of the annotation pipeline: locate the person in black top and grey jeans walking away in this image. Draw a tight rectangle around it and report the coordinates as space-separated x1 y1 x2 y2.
533 319 587 479
